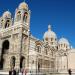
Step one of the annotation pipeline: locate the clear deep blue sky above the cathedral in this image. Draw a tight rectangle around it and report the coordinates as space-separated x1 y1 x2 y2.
0 0 75 47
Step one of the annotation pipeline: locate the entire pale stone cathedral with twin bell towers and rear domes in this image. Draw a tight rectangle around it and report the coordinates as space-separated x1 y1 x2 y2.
0 2 75 73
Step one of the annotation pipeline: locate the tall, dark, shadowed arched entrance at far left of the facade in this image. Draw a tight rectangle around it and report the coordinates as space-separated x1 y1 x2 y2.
0 40 9 69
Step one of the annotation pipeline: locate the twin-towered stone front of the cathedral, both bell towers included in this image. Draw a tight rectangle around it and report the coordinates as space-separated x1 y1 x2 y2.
0 2 30 70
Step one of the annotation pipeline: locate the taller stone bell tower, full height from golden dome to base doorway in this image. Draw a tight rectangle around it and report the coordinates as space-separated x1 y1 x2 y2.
14 2 30 69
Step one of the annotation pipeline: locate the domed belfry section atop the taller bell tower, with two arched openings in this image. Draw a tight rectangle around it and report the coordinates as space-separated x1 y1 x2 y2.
14 2 30 29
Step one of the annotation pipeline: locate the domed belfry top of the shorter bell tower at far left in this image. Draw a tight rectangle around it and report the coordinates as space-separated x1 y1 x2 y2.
0 11 12 29
